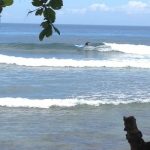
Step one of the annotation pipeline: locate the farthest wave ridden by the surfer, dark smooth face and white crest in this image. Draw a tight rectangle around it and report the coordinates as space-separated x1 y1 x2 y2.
0 42 150 55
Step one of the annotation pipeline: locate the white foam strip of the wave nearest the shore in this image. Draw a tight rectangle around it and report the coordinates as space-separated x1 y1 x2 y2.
0 97 150 108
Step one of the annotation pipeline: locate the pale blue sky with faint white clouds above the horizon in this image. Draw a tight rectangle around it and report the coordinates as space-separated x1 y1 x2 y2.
1 0 150 26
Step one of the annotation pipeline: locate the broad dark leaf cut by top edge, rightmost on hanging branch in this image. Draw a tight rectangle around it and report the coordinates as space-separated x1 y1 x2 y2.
47 0 63 10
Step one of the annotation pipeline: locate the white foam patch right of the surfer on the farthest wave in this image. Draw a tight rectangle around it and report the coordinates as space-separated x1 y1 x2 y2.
105 43 150 55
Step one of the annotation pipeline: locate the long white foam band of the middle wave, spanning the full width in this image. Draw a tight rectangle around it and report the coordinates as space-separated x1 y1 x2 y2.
0 55 150 68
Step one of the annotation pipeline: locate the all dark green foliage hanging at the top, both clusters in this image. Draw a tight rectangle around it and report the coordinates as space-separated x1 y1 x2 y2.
0 0 63 41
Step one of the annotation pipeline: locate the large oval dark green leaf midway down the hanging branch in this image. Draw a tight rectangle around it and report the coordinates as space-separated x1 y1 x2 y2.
44 8 56 23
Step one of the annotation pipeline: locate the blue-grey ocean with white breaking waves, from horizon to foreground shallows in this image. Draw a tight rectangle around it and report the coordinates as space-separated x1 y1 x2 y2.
0 24 150 150
